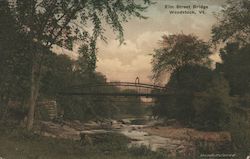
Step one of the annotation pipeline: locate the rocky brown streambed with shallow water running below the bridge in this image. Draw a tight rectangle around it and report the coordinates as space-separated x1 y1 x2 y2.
30 119 231 157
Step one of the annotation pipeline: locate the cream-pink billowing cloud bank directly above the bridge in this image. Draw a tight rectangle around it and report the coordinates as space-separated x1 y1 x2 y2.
97 31 169 82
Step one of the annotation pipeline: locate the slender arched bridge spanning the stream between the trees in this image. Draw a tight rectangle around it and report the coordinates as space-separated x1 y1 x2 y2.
58 77 166 98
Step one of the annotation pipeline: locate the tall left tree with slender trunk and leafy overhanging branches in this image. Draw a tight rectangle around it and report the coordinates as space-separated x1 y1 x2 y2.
8 0 151 129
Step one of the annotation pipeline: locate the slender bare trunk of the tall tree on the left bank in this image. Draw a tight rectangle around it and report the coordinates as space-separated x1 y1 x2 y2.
27 62 41 130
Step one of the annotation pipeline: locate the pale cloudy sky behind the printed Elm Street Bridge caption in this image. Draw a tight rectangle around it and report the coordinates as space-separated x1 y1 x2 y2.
54 0 225 83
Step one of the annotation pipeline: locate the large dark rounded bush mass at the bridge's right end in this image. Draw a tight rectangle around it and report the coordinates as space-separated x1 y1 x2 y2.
154 65 230 130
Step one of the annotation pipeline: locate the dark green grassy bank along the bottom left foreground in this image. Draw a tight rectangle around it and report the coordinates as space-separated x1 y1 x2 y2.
0 123 169 159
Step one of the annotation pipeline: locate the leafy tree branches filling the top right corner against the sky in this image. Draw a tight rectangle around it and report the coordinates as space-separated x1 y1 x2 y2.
212 0 250 45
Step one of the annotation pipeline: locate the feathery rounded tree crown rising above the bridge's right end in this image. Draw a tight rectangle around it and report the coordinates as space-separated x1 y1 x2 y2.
151 34 212 80
